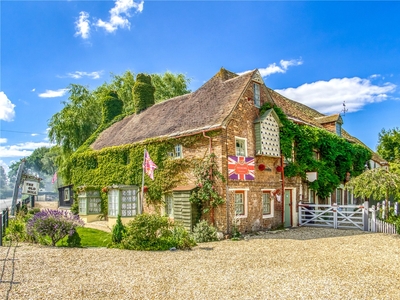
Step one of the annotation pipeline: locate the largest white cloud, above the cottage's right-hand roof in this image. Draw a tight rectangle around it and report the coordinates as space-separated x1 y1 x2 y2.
276 77 396 114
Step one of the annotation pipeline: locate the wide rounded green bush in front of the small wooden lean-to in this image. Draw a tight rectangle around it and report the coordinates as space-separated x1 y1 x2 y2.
121 214 195 250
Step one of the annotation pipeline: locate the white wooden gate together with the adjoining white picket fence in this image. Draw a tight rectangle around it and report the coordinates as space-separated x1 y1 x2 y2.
299 202 400 234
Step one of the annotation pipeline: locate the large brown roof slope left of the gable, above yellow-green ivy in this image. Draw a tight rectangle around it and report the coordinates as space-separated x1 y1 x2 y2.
91 69 253 150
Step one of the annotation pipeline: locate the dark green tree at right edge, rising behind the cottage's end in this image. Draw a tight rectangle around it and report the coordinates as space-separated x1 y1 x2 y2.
378 127 400 163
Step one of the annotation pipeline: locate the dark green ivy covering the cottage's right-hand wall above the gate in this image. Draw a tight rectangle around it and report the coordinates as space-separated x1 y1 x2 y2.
260 103 372 198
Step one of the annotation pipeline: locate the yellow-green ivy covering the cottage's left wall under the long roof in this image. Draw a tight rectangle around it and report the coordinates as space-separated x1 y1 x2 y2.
65 132 220 214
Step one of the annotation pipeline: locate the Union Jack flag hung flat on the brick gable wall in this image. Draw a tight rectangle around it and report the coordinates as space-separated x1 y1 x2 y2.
228 156 255 180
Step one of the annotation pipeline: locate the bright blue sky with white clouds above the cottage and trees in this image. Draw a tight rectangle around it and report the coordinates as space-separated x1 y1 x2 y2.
0 0 400 172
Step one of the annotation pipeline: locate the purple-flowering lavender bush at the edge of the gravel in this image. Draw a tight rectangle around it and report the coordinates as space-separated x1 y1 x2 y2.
27 209 84 246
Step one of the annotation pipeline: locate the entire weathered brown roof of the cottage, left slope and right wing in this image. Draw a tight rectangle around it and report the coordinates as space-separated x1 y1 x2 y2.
91 68 385 164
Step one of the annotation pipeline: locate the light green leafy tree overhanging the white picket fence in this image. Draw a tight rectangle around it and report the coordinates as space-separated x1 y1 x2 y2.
346 168 400 202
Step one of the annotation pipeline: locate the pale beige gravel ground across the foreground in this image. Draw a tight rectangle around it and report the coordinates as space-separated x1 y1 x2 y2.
0 228 400 300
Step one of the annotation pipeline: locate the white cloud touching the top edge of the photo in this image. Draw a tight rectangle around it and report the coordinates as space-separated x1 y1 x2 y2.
95 0 144 32
